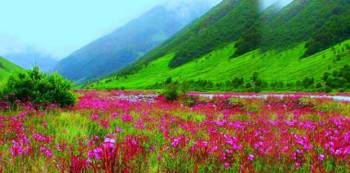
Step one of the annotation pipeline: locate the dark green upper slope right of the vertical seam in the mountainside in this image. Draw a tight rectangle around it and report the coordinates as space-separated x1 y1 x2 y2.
262 0 350 55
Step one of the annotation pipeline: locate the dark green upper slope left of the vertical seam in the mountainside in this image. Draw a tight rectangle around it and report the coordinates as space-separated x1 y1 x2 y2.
122 0 259 73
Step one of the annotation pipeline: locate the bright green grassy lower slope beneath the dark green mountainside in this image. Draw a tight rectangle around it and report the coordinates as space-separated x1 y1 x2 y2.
90 40 350 89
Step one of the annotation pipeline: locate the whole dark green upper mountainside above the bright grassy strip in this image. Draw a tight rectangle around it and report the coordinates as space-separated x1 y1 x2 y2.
117 0 350 76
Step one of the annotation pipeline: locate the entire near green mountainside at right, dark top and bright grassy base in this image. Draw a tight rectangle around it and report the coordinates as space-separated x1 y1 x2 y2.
88 0 350 89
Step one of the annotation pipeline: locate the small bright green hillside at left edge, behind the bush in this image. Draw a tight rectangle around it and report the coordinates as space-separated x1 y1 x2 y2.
0 57 23 88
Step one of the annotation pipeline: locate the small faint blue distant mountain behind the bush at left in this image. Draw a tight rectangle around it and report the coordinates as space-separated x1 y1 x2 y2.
5 49 57 72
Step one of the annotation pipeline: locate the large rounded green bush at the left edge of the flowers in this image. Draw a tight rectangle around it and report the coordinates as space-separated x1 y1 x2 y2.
1 67 75 107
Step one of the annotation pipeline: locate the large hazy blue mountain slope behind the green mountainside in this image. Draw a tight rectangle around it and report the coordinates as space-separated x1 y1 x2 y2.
56 0 217 83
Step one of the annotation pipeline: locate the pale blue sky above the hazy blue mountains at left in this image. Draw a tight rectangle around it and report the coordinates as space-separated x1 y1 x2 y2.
0 0 165 58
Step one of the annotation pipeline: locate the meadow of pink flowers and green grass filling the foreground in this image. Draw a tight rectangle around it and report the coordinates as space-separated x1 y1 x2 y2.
0 91 350 173
